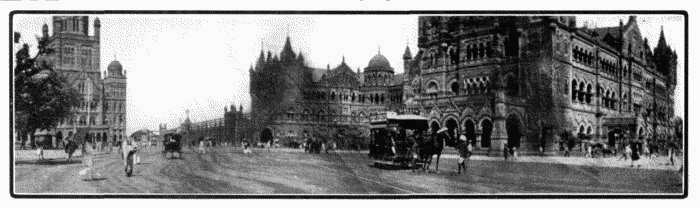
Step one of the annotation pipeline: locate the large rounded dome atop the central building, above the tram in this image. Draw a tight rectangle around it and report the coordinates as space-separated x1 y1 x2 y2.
364 49 394 86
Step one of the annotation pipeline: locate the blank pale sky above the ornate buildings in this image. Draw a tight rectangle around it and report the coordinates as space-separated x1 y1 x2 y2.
13 15 685 134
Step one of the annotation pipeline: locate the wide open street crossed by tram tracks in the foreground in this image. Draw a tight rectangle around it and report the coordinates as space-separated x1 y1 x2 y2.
14 147 683 194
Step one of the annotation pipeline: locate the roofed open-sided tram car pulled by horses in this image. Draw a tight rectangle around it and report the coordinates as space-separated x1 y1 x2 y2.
369 112 428 168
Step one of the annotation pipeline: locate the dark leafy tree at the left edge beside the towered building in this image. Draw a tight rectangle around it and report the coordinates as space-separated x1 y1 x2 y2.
11 33 79 148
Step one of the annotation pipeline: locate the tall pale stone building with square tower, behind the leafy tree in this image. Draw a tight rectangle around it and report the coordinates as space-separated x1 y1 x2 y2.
36 16 127 145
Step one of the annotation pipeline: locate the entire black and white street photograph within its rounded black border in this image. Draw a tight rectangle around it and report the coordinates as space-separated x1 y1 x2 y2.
5 10 688 198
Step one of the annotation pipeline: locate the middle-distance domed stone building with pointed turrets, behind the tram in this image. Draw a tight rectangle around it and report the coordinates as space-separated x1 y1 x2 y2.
249 37 403 145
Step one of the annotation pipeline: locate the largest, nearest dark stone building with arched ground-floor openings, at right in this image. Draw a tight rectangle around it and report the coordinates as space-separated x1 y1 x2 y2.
403 16 677 150
